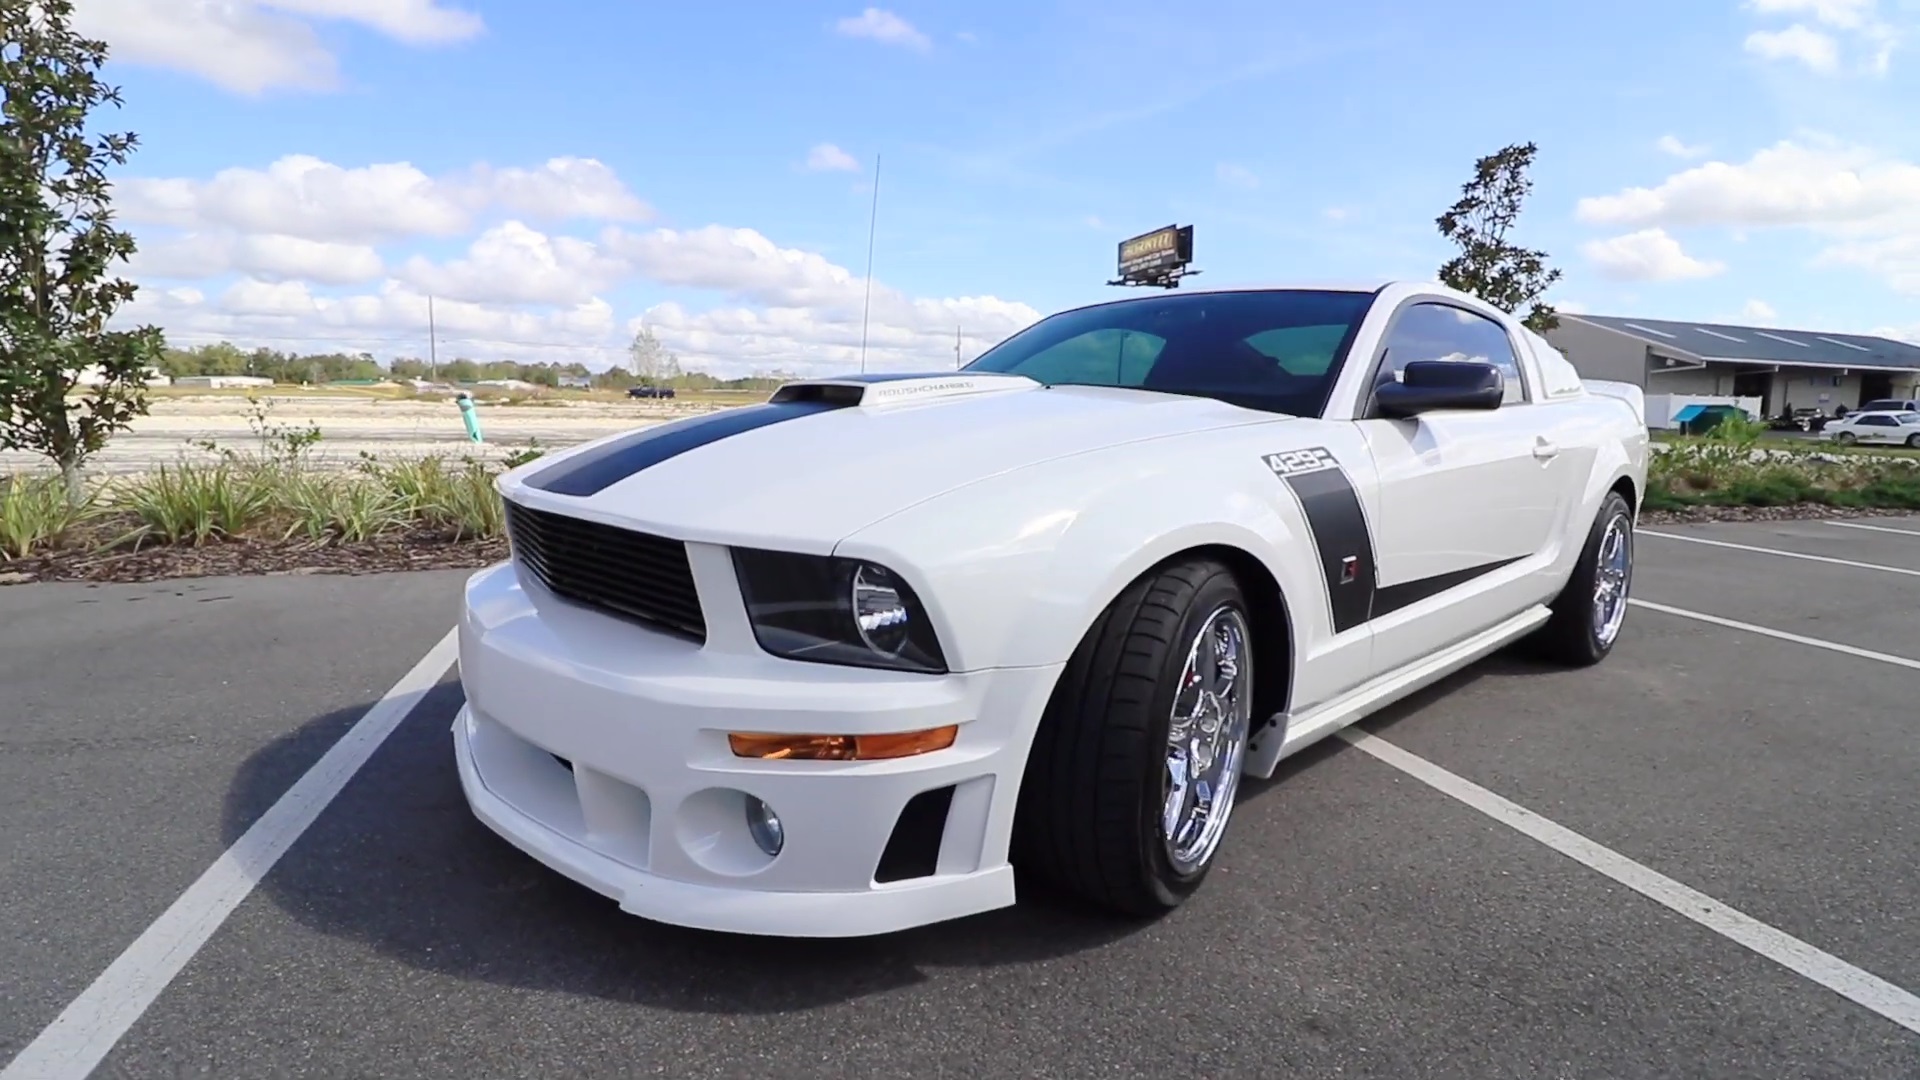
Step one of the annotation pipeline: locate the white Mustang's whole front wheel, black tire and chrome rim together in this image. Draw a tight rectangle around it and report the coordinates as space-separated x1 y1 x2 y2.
1014 559 1254 915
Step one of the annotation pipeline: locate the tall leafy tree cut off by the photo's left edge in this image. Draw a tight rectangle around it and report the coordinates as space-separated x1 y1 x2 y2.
0 0 165 500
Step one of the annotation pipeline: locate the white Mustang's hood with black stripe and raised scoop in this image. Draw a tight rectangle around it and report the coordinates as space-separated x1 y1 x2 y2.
501 373 1290 555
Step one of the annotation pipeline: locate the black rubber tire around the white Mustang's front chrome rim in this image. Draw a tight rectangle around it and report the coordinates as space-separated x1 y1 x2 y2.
1012 559 1258 917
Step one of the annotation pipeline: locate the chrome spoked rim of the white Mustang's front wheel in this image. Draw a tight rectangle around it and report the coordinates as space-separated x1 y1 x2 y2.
1160 603 1254 874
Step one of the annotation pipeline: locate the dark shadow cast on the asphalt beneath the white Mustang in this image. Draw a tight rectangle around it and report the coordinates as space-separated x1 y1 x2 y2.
223 638 1540 1015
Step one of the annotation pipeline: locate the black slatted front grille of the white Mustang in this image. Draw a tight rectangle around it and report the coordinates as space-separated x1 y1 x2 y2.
507 502 707 644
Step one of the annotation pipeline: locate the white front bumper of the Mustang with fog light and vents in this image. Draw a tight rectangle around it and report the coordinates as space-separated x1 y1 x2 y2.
453 563 1060 936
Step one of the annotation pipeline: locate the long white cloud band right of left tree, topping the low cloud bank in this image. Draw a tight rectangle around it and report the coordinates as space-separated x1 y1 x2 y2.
115 154 651 242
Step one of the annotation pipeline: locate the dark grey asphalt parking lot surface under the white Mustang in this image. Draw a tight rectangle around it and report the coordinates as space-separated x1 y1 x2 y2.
0 517 1920 1080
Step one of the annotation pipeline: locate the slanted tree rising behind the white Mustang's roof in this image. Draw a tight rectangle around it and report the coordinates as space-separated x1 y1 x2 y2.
1438 142 1561 332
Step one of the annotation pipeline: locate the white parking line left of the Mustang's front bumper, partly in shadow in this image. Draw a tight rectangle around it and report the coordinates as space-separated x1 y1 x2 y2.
0 630 459 1080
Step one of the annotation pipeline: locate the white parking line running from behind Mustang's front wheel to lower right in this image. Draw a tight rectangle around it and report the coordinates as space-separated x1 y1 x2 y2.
1338 728 1920 1034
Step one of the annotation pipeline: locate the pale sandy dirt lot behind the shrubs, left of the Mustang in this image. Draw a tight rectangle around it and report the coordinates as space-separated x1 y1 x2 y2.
0 392 737 475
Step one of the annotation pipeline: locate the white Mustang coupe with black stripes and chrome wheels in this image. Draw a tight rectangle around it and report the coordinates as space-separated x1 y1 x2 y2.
453 282 1647 936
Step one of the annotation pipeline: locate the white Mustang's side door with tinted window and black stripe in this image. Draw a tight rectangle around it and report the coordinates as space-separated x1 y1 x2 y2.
1356 300 1578 675
